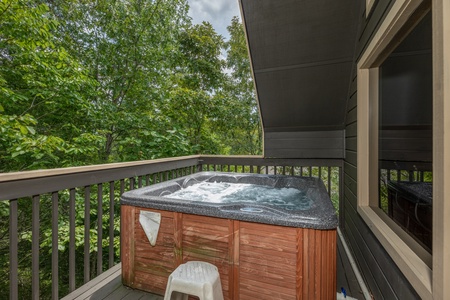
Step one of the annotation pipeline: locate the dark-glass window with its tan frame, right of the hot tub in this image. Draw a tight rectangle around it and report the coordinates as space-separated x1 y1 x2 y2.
357 0 434 299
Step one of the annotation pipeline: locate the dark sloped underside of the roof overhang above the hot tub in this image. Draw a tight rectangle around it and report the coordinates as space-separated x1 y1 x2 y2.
240 0 361 157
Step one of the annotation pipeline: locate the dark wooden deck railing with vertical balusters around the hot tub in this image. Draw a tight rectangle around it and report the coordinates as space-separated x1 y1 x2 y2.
0 155 343 299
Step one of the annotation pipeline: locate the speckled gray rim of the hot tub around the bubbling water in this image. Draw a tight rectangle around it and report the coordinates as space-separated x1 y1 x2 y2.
121 172 338 230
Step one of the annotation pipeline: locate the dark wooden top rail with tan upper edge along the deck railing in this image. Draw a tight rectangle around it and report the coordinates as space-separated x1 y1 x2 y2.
0 155 343 201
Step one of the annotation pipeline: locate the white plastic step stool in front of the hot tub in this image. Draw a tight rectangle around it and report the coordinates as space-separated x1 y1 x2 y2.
164 261 223 300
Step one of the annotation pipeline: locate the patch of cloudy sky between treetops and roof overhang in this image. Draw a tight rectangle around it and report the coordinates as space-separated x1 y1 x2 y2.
188 0 241 39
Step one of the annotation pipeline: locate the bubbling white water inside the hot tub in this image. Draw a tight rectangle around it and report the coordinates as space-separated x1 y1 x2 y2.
163 182 312 210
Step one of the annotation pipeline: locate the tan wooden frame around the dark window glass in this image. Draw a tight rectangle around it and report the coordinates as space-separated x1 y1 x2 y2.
357 0 450 299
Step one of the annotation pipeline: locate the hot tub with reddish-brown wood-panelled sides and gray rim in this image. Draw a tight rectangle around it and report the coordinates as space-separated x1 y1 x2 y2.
121 172 338 300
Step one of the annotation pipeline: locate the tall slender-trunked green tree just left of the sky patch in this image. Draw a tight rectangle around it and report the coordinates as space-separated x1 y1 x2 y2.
48 0 193 161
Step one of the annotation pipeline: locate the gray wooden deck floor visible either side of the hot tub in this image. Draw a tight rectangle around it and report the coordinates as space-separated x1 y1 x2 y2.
63 232 364 300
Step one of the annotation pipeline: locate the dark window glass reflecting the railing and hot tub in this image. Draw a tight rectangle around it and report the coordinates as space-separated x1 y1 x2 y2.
378 13 433 252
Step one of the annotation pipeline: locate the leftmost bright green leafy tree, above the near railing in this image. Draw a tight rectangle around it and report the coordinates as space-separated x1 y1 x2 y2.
0 0 95 171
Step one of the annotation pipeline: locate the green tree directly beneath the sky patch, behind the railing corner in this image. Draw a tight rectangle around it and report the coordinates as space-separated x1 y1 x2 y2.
162 22 225 153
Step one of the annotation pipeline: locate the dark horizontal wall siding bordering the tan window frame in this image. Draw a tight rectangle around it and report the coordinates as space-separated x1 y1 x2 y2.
341 0 419 299
